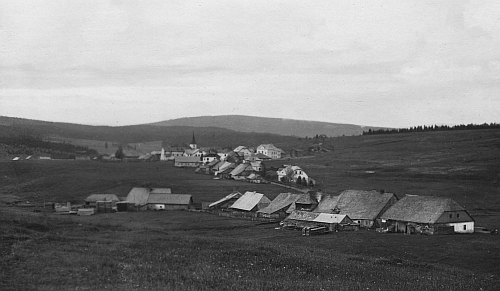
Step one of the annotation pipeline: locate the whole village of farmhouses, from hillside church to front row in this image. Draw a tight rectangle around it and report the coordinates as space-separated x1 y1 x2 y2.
47 133 484 236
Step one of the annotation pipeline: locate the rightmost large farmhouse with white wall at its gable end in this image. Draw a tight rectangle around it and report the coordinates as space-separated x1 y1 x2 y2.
381 195 474 233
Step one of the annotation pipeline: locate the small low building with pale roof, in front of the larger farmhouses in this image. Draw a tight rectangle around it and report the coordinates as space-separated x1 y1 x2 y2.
282 210 354 231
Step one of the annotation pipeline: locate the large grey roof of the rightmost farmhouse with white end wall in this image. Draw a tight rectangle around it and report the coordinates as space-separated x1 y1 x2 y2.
381 195 465 224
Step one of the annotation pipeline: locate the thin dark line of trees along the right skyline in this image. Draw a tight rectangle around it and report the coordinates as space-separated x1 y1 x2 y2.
363 123 500 135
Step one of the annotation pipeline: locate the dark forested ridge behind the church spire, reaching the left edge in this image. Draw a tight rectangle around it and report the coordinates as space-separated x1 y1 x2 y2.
0 116 296 146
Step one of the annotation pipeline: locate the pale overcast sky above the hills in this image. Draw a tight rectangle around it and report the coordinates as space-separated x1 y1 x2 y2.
0 0 500 127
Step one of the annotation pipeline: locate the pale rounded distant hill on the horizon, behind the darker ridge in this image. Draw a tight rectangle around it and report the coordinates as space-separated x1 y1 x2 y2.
148 115 381 137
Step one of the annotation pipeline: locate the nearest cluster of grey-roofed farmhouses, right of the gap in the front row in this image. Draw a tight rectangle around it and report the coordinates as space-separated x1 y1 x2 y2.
207 190 474 234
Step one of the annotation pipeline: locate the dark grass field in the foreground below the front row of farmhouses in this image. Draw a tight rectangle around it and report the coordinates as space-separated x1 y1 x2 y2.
0 208 500 290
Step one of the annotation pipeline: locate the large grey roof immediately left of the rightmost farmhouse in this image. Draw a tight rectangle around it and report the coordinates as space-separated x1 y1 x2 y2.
337 190 395 220
